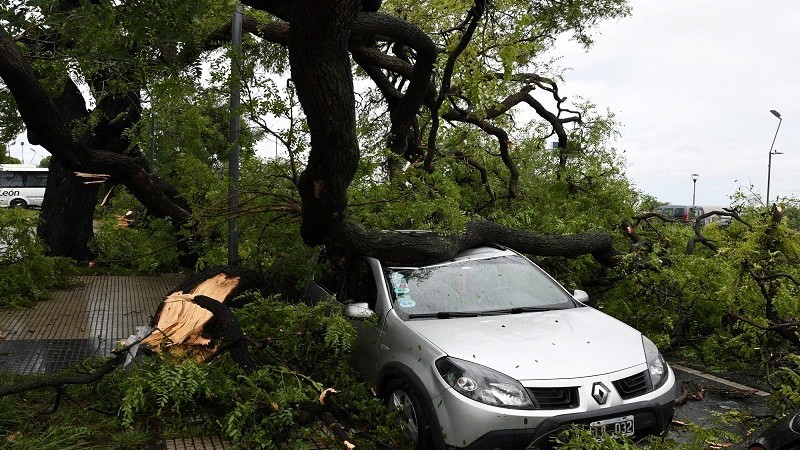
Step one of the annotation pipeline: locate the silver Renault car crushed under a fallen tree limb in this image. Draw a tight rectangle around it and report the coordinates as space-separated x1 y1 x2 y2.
307 247 675 450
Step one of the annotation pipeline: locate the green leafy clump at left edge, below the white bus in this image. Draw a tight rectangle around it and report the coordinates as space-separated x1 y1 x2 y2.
0 209 77 308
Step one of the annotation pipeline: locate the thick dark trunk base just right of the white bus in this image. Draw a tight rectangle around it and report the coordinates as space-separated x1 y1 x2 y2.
36 158 98 261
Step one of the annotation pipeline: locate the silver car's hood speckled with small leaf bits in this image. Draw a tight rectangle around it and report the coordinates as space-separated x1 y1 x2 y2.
406 307 645 381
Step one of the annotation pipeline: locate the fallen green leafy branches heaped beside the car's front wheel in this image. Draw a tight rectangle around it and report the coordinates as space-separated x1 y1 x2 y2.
111 294 402 448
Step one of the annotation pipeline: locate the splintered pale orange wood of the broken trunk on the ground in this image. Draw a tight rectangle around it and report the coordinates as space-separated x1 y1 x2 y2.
142 273 239 361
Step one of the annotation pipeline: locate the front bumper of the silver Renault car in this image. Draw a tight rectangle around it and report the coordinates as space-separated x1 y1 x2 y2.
430 368 675 450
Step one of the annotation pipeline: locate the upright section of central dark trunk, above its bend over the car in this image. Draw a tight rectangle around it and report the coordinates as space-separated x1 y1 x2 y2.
289 0 361 245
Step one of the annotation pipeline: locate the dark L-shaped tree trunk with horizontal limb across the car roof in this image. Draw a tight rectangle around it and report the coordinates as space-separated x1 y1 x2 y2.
272 0 619 265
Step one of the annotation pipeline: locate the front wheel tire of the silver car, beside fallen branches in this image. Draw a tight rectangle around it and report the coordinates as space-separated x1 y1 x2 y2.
385 378 433 450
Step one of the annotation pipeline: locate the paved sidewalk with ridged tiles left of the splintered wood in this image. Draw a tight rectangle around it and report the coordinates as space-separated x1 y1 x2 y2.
0 274 185 374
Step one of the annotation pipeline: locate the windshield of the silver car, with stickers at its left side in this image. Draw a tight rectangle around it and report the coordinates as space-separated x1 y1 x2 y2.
384 255 575 320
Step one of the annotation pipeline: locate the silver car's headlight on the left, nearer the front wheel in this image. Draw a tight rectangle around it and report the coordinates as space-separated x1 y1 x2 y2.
436 357 534 409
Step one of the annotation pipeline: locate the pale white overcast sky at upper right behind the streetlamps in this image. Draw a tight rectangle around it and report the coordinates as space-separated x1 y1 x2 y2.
558 0 800 205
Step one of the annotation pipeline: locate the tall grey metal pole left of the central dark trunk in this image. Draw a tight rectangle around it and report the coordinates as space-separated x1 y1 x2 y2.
228 4 242 266
